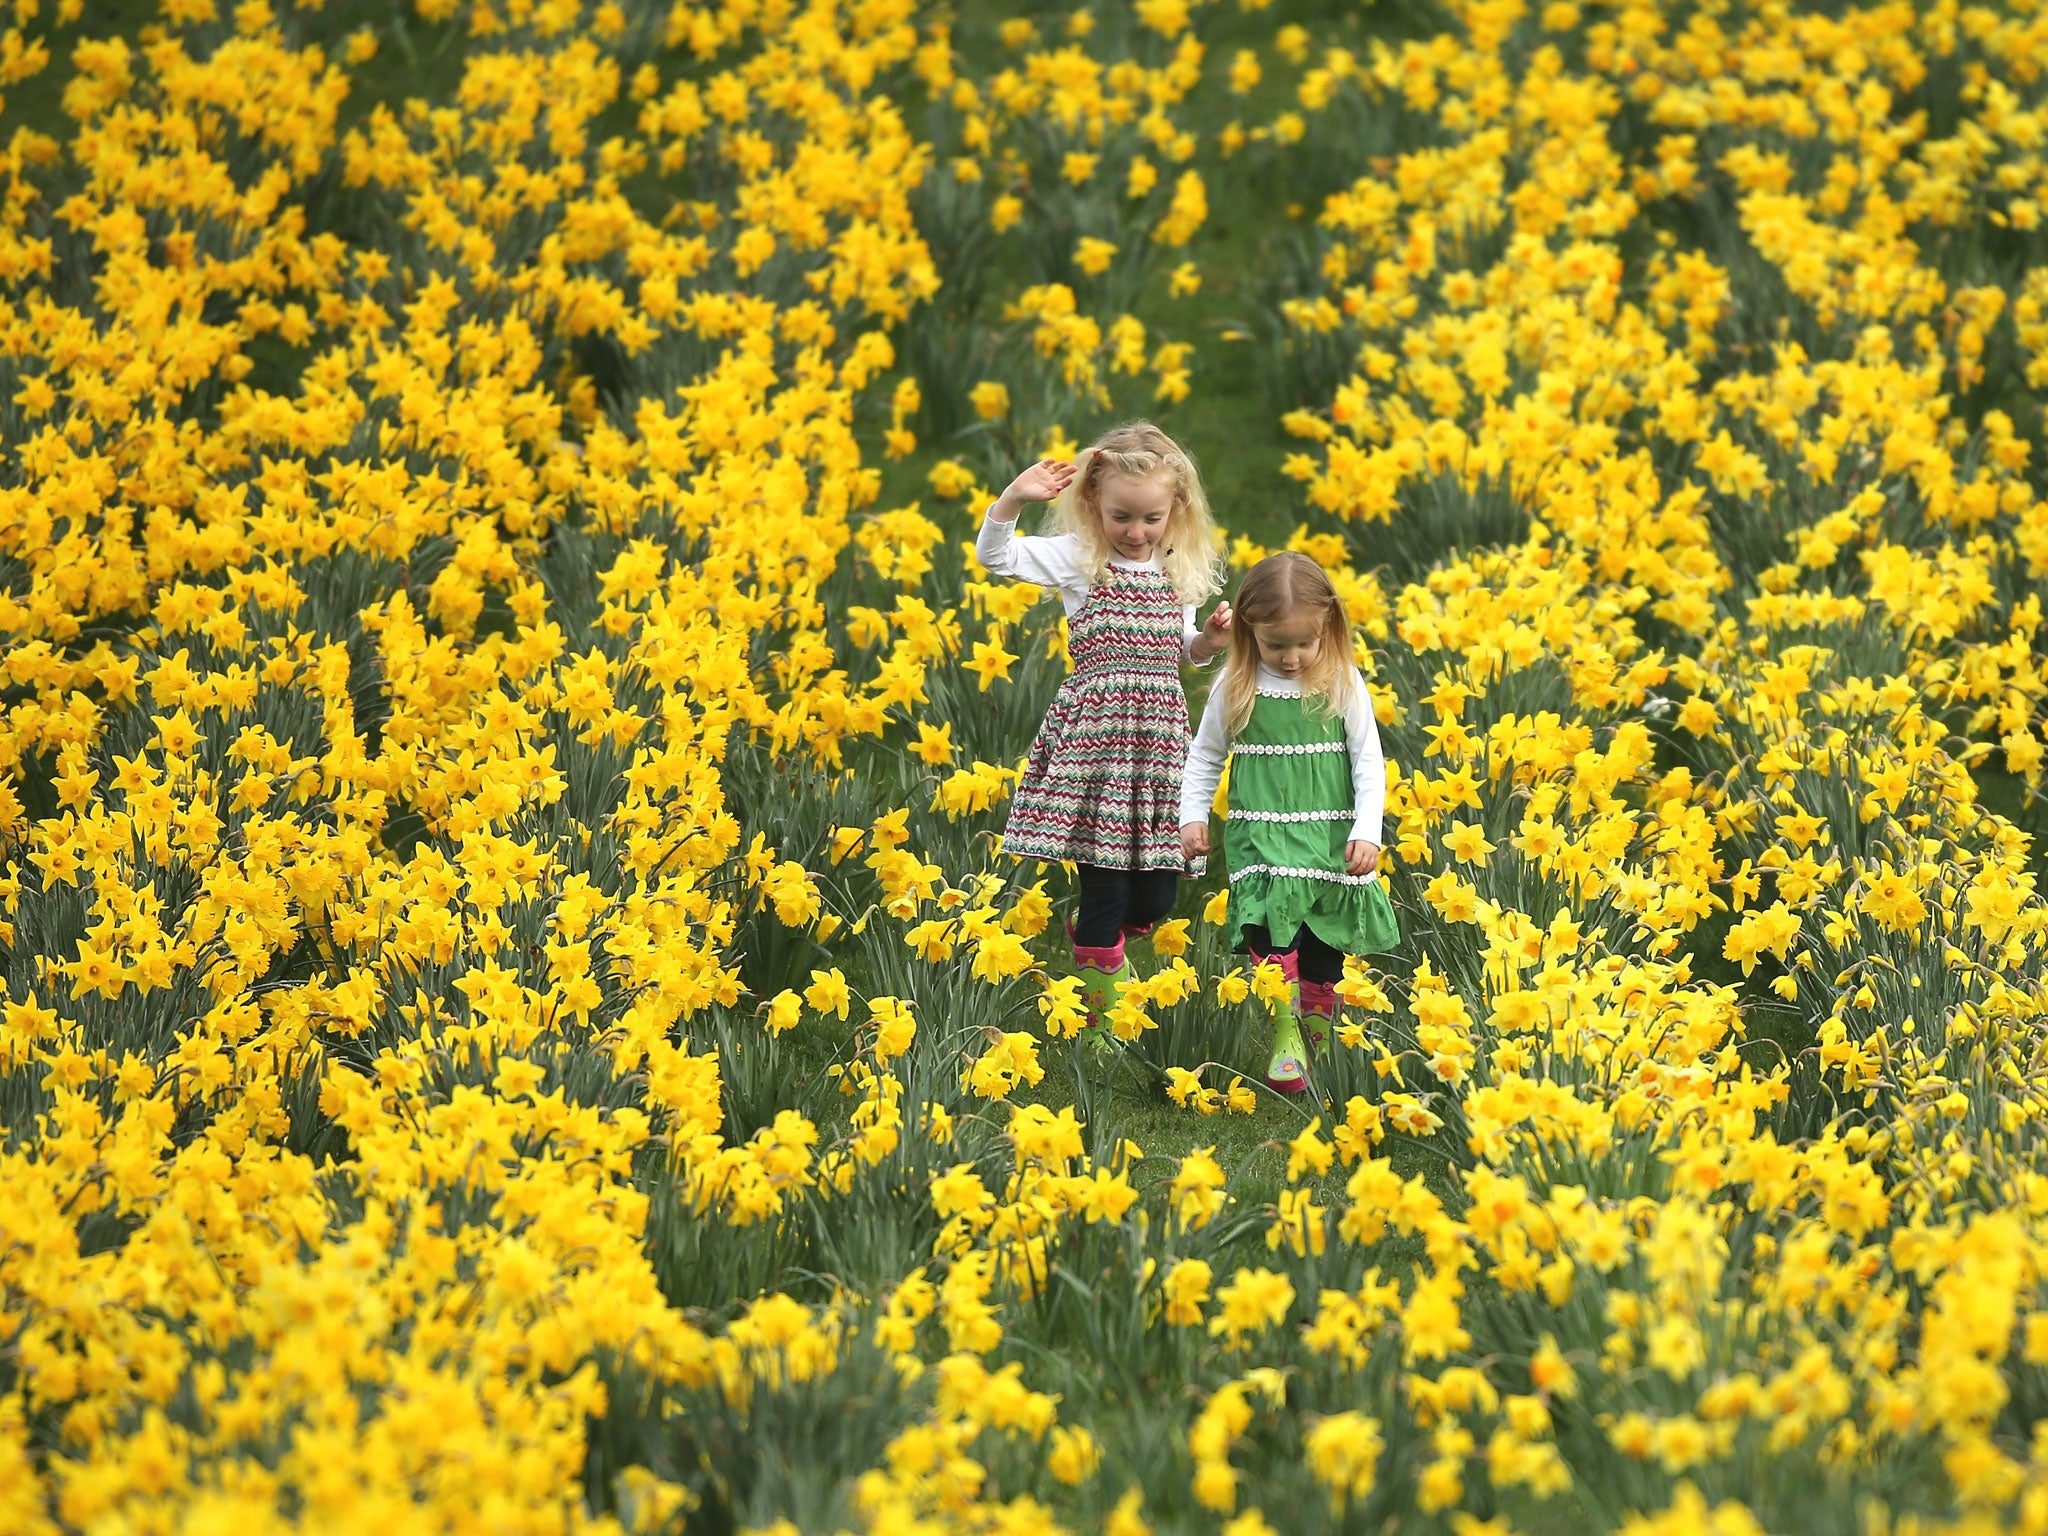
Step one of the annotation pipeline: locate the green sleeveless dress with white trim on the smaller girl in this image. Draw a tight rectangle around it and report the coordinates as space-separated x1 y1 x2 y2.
1223 692 1401 954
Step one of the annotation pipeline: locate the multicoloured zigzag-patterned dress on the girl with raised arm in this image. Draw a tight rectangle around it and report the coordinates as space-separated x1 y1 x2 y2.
1004 565 1188 870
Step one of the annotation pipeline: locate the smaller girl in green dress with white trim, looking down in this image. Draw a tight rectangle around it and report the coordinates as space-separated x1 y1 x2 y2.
1180 553 1401 1094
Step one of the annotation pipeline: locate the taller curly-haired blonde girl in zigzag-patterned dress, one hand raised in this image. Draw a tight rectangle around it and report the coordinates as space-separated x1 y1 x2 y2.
975 422 1231 1020
